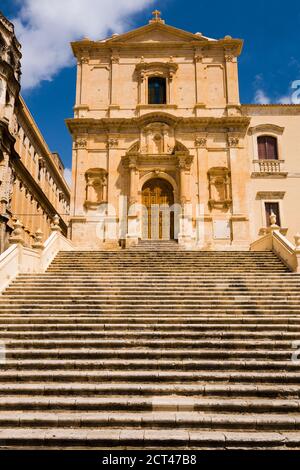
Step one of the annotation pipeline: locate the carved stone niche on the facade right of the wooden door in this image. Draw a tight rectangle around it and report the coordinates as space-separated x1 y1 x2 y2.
208 167 232 210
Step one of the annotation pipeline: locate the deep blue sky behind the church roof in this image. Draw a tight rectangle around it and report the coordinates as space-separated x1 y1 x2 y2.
0 0 300 176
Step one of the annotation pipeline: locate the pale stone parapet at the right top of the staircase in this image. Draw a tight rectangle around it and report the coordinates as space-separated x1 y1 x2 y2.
250 228 300 273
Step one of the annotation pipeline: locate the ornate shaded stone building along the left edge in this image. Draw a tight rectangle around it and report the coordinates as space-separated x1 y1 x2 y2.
0 13 70 252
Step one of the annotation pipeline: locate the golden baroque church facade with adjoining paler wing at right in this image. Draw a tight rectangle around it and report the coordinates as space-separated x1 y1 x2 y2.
67 11 300 250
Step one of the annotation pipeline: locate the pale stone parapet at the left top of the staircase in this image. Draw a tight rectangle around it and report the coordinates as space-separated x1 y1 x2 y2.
0 232 74 293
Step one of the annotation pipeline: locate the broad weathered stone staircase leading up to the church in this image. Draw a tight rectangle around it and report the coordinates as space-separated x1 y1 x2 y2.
0 250 300 449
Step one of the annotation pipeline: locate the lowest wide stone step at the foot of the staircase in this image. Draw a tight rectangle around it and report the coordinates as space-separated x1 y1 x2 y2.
0 426 300 450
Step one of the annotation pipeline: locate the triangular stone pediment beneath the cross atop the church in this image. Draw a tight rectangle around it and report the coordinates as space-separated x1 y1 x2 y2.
107 23 209 44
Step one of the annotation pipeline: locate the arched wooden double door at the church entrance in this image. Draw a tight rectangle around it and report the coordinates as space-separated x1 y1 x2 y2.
142 178 174 240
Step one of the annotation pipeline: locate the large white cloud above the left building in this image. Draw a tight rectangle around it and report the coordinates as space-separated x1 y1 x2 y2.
12 0 155 89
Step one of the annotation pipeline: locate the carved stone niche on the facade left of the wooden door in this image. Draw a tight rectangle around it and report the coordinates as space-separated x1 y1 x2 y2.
85 168 107 208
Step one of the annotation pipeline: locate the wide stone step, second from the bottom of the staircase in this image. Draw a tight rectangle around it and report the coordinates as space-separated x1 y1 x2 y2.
0 411 300 431
